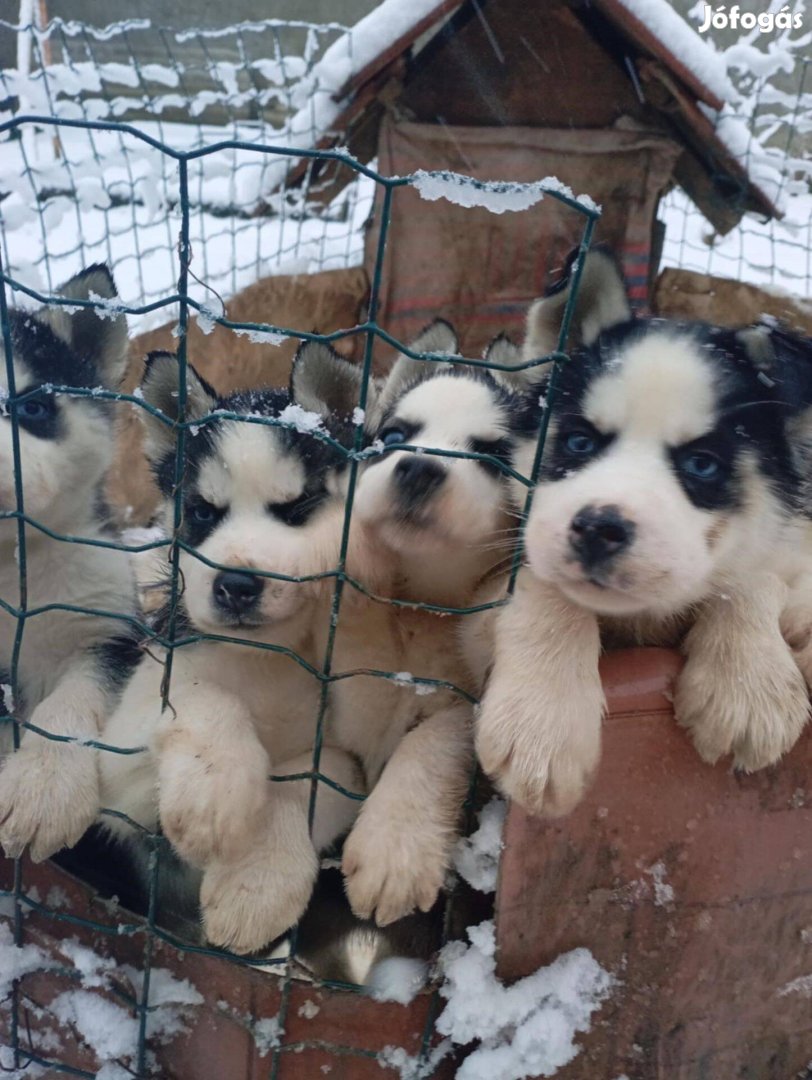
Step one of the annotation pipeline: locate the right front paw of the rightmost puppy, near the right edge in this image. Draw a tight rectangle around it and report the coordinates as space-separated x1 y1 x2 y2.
674 638 809 772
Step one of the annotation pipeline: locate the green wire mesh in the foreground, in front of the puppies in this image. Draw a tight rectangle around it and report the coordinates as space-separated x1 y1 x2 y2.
0 97 599 1077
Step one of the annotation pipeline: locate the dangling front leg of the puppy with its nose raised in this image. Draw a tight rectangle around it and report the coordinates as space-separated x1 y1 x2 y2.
342 702 473 927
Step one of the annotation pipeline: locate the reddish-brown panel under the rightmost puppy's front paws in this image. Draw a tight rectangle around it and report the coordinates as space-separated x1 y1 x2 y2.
497 649 812 1080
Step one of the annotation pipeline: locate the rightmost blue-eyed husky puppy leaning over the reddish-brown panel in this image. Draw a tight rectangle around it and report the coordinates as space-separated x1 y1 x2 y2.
468 251 812 814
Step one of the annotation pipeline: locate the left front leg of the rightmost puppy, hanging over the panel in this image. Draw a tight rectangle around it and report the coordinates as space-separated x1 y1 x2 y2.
476 569 604 815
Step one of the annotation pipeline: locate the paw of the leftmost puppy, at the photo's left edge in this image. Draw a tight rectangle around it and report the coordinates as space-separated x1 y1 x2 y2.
0 735 99 863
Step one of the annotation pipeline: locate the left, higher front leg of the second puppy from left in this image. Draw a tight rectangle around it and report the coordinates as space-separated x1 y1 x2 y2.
154 683 271 866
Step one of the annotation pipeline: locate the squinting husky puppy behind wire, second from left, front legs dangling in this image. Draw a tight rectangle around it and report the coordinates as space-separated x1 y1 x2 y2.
100 353 361 953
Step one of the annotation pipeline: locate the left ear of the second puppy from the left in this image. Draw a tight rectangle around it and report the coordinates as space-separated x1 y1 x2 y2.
138 352 217 463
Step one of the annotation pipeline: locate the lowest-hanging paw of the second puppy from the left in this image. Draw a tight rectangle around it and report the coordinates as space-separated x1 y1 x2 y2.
200 843 319 954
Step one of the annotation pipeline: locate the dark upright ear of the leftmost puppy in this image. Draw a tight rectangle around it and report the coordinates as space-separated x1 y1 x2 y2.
37 262 128 390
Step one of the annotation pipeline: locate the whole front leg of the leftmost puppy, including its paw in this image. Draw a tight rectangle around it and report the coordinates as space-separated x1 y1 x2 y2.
0 660 108 863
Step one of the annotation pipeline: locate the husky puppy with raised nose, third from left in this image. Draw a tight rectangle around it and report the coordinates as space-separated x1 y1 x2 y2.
294 322 532 926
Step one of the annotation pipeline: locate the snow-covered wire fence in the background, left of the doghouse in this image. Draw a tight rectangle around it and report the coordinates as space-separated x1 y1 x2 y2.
0 18 373 315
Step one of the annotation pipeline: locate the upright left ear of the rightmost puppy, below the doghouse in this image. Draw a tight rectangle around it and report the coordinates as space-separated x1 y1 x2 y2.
522 247 632 362
